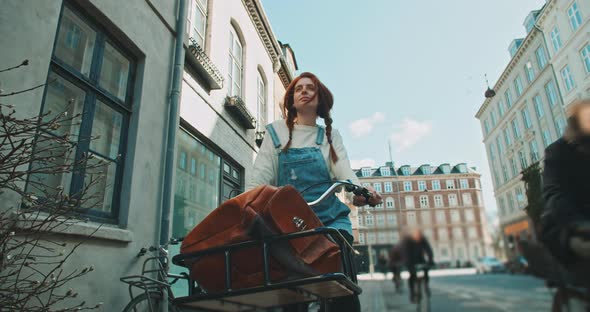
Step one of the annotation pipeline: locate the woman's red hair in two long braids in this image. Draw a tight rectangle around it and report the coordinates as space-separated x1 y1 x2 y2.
283 72 338 163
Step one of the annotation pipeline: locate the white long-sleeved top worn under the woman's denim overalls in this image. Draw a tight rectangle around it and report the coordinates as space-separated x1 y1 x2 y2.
246 119 359 194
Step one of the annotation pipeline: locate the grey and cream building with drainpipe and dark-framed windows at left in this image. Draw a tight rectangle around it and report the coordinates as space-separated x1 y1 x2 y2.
0 0 297 311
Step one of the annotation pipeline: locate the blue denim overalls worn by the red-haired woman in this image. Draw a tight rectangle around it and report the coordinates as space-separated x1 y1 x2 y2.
266 124 352 235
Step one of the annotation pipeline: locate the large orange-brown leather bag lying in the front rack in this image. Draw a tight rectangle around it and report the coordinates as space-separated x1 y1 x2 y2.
180 185 341 292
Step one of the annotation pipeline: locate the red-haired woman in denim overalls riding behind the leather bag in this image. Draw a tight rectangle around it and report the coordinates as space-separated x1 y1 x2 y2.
246 72 381 311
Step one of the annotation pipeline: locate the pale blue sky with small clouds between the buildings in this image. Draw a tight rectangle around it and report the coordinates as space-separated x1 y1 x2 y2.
262 0 545 222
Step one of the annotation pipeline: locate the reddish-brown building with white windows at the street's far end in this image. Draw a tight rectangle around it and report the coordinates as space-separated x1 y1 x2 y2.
351 162 492 270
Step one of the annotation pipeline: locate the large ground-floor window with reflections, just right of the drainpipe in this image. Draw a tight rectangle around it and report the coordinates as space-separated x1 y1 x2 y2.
172 128 227 237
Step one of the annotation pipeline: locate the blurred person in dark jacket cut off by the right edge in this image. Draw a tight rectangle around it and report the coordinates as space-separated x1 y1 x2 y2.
541 99 590 280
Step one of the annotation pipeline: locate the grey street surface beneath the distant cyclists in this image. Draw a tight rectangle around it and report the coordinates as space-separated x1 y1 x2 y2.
359 269 552 312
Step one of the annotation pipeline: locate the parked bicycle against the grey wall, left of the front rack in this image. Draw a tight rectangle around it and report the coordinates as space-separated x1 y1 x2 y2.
120 238 193 312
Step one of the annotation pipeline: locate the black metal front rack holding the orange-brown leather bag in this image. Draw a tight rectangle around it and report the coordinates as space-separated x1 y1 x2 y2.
172 227 362 311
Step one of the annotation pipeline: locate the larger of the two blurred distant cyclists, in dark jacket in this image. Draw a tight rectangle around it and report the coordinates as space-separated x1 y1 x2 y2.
402 229 434 302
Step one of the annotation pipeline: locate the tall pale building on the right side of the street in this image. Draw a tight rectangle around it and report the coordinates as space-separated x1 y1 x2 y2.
476 0 590 257
